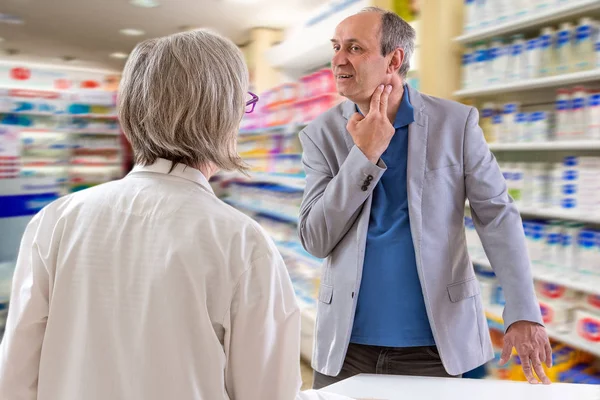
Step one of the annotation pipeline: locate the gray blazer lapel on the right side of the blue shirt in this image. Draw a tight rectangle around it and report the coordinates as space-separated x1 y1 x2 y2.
406 85 428 260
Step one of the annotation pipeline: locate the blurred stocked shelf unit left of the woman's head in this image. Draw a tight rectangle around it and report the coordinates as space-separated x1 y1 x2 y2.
0 87 126 194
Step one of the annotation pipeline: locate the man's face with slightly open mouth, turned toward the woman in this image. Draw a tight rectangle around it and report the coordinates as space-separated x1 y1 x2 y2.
331 12 389 103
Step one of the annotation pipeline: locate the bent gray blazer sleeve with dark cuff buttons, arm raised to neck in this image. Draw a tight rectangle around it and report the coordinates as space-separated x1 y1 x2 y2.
298 131 386 258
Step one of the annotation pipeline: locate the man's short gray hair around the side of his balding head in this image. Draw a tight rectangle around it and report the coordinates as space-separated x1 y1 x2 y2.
360 7 417 78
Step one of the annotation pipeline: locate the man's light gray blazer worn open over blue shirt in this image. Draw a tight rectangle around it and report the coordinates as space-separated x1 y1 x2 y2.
299 87 542 376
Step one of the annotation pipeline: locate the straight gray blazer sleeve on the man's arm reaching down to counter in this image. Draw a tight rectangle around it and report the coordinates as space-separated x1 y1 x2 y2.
463 108 543 329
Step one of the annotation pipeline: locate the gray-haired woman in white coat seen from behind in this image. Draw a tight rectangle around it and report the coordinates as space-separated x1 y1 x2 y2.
0 30 350 400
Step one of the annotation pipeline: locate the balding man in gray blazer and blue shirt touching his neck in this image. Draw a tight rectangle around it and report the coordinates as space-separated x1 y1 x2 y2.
299 8 552 388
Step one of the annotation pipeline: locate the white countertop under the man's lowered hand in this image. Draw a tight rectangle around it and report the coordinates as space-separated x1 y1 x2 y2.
322 375 600 400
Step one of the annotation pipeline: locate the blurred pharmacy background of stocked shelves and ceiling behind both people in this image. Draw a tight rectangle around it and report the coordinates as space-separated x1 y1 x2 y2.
0 0 600 390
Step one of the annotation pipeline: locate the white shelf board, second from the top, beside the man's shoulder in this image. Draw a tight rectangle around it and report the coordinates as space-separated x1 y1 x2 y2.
454 68 600 98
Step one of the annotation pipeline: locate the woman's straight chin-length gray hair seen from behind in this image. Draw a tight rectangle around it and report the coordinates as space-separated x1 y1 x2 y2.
118 30 249 171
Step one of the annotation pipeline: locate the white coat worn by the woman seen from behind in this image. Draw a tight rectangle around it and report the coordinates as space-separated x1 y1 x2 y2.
0 160 350 400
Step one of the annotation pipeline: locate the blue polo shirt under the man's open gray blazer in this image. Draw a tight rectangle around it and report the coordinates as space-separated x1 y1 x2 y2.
350 86 435 347
